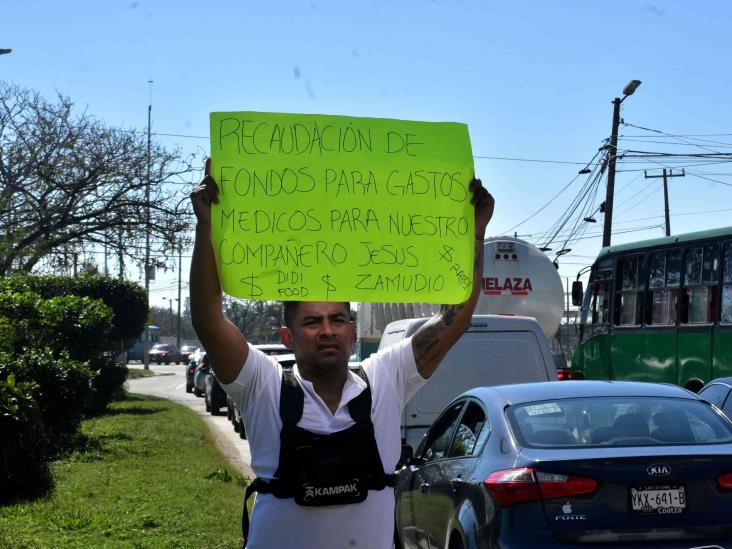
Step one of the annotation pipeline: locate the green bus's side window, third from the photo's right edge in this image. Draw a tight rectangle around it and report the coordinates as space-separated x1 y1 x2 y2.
648 250 681 326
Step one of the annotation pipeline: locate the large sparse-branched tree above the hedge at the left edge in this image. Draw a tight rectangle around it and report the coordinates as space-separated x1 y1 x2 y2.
0 81 193 276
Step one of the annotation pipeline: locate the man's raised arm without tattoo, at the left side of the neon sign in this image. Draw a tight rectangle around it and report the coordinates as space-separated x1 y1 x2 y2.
190 159 249 383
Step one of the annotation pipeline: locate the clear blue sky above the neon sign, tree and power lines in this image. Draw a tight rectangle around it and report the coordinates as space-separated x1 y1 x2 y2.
0 0 732 305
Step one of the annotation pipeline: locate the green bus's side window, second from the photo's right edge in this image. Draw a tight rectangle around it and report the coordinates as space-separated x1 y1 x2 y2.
681 245 719 324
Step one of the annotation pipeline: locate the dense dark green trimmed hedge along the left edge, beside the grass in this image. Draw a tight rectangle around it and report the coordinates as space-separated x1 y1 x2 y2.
0 276 147 500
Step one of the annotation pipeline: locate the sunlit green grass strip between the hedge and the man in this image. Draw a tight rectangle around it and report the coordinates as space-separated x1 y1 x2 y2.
0 395 245 549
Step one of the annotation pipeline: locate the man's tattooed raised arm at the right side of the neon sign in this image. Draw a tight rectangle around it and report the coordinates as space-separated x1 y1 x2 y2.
412 179 494 379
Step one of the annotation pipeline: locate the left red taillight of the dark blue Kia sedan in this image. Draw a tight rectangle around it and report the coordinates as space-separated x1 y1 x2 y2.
483 467 597 507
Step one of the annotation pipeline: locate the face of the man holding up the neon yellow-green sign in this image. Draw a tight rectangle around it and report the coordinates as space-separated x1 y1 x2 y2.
280 301 355 371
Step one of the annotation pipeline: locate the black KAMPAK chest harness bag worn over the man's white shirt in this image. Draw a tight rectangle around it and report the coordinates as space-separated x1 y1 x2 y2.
241 368 396 545
